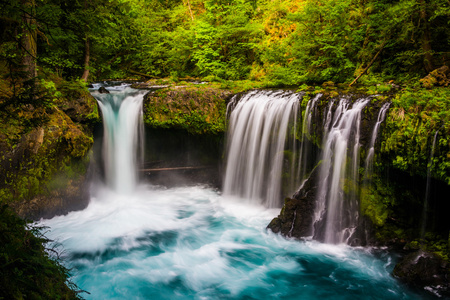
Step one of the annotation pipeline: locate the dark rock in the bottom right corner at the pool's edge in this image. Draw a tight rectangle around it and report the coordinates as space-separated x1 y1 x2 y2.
393 250 450 297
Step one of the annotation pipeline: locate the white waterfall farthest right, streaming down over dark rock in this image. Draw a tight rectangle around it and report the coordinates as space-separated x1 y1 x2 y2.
314 98 370 244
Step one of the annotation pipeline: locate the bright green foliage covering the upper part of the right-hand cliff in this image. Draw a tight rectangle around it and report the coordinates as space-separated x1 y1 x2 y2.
381 88 450 184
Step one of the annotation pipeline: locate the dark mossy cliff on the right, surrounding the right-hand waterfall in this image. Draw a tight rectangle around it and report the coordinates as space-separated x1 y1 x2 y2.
268 89 450 296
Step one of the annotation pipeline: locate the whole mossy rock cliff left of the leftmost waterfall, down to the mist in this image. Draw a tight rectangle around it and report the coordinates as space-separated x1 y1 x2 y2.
0 84 98 219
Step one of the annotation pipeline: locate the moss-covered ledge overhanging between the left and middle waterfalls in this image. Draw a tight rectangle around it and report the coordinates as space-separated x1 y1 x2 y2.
144 84 233 134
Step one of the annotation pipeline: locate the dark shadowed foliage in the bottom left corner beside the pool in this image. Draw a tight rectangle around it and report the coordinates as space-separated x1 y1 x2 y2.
0 204 80 299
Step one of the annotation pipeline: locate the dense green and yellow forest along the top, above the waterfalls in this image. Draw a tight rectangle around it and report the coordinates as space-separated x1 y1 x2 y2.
0 0 450 87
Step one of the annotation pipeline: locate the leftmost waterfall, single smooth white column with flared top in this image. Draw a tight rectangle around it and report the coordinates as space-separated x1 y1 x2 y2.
92 86 147 193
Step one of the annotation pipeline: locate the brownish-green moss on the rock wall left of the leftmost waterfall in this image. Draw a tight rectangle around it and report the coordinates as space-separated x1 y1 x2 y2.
0 86 93 203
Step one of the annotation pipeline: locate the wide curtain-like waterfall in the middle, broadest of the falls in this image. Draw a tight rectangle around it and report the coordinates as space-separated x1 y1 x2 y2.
224 91 300 207
